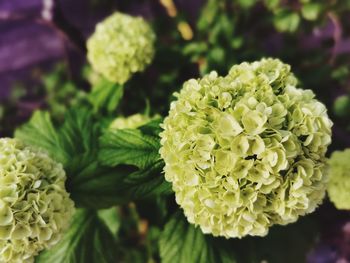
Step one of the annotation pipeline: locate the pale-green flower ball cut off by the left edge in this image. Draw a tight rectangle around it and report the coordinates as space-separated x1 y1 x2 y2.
0 138 74 262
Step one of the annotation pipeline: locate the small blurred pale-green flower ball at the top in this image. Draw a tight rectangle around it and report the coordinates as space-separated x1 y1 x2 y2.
87 12 155 84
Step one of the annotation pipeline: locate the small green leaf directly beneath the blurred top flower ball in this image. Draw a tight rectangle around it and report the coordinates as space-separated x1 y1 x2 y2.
88 79 124 113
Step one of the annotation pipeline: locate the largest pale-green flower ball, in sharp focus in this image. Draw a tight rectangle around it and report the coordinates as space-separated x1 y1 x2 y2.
160 59 332 238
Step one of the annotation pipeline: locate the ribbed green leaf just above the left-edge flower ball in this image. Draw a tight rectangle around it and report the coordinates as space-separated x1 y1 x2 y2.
15 111 67 163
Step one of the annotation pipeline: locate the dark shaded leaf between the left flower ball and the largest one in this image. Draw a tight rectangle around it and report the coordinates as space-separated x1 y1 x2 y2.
67 161 172 208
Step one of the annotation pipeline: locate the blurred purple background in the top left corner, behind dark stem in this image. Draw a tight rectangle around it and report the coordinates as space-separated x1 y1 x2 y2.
0 0 107 100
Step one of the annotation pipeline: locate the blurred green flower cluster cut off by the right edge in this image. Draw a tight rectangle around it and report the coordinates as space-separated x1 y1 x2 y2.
327 149 350 210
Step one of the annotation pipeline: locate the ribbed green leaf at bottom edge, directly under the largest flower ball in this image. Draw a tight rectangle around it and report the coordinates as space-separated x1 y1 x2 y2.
159 212 236 263
